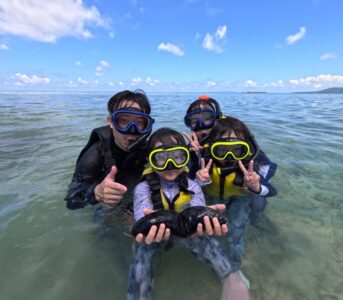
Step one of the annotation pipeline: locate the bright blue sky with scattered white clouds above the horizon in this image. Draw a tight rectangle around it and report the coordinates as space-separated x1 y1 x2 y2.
0 0 343 92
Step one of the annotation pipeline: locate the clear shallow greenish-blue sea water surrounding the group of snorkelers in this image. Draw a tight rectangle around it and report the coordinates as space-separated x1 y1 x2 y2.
0 92 343 300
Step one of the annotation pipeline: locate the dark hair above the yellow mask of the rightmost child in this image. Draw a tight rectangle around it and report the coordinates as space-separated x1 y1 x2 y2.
209 117 251 143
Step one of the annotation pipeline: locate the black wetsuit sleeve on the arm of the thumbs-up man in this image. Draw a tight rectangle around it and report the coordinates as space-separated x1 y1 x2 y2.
64 143 105 209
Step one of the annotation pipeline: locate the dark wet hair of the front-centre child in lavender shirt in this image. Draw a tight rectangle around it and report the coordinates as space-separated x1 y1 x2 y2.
148 127 186 152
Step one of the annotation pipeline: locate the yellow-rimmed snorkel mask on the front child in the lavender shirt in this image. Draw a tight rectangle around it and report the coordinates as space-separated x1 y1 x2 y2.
149 146 190 171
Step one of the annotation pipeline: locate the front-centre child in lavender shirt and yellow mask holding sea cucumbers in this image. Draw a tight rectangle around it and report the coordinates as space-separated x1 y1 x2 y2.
127 128 250 300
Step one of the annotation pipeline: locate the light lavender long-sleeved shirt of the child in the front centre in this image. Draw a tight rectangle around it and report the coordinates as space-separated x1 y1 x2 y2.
133 179 206 221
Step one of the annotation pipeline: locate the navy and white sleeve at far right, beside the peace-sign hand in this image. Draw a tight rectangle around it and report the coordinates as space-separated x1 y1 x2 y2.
254 150 277 197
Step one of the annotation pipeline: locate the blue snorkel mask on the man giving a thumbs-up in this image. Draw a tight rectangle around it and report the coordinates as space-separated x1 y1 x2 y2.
111 108 155 136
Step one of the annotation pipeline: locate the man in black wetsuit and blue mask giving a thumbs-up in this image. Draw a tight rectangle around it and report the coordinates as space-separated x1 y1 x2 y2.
65 90 154 209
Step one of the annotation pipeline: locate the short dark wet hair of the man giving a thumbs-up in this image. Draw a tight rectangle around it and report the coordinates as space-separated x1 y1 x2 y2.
107 90 151 114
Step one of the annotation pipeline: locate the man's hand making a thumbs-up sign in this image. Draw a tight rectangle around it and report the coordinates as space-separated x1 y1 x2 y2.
94 166 127 206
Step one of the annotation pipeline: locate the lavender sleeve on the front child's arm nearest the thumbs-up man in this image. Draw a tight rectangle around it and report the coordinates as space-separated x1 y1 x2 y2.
133 181 154 221
